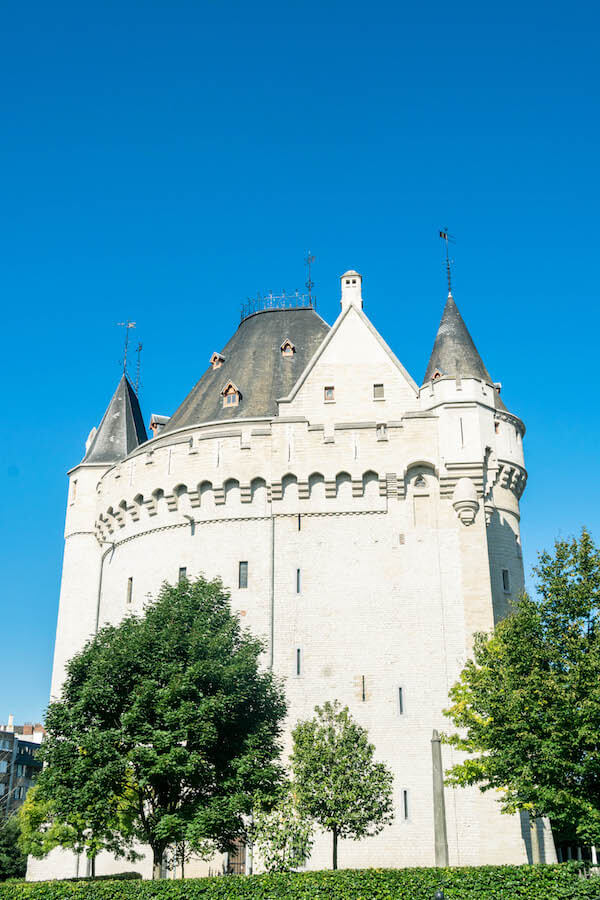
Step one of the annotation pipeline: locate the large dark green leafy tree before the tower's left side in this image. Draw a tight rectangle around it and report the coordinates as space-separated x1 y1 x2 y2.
29 578 285 877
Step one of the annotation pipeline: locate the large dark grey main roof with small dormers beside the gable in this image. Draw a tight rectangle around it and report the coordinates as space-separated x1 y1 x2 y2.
161 307 329 436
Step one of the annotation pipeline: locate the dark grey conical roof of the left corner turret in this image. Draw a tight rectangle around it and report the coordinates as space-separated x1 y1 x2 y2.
83 375 148 463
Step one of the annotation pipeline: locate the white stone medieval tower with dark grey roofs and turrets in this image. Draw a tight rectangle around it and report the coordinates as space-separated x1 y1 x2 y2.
29 270 554 878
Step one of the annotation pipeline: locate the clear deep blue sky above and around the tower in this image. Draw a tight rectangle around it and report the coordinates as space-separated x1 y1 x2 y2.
0 0 600 721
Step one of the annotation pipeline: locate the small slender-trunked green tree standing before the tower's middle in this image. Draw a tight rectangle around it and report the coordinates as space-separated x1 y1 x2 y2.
291 700 394 869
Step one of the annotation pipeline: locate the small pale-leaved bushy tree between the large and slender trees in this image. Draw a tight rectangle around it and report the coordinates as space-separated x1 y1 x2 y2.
252 785 313 872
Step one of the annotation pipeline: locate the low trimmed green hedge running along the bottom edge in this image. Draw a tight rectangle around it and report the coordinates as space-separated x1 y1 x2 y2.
0 864 600 900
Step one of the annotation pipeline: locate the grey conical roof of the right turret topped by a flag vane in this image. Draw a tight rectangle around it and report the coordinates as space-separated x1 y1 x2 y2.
423 293 492 384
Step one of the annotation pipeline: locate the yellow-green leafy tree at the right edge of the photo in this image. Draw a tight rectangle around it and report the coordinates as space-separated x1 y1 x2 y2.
446 529 600 844
